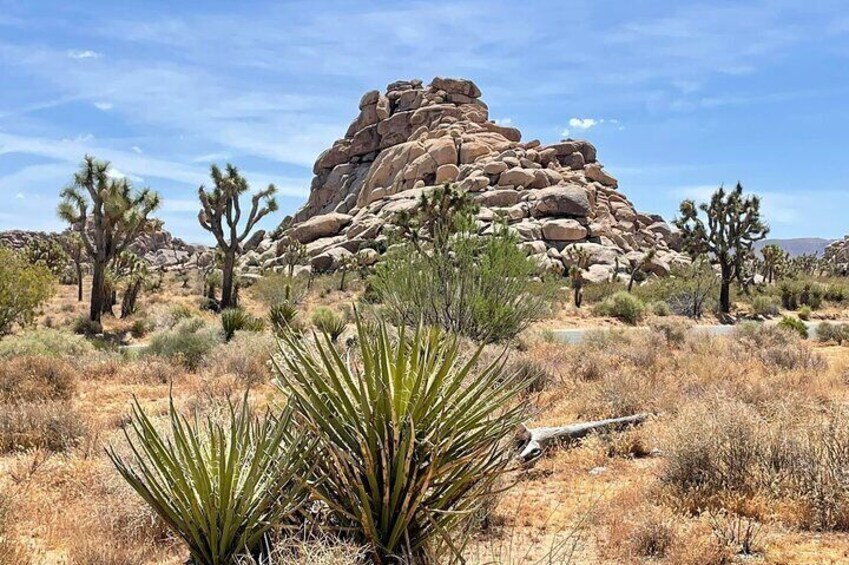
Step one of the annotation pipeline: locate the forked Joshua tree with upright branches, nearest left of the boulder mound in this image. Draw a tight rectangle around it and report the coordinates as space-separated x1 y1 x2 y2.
198 164 277 309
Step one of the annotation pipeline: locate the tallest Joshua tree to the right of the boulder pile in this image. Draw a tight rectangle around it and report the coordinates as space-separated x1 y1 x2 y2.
675 183 769 314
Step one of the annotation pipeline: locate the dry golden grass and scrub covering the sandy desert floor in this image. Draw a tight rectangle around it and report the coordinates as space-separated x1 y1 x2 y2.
0 277 849 565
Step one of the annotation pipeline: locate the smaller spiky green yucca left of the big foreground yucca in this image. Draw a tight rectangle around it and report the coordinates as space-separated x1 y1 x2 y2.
107 399 304 565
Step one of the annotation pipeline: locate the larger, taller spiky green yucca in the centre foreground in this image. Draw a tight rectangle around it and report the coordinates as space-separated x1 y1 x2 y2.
274 320 522 564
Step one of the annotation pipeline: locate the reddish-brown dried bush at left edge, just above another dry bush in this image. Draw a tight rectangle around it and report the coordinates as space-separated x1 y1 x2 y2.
0 356 77 403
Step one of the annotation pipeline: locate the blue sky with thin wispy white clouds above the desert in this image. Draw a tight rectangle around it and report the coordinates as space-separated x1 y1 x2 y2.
0 0 849 242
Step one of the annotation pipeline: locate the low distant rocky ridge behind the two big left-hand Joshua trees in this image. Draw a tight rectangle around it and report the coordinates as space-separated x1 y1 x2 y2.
0 229 210 270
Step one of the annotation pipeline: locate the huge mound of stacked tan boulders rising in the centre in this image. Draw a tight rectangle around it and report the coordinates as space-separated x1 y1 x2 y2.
245 78 681 280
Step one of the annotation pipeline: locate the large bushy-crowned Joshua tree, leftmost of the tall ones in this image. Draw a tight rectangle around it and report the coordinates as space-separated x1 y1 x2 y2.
58 155 159 322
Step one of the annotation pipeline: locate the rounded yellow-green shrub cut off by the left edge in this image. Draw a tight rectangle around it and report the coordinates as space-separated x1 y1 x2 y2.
0 247 54 337
